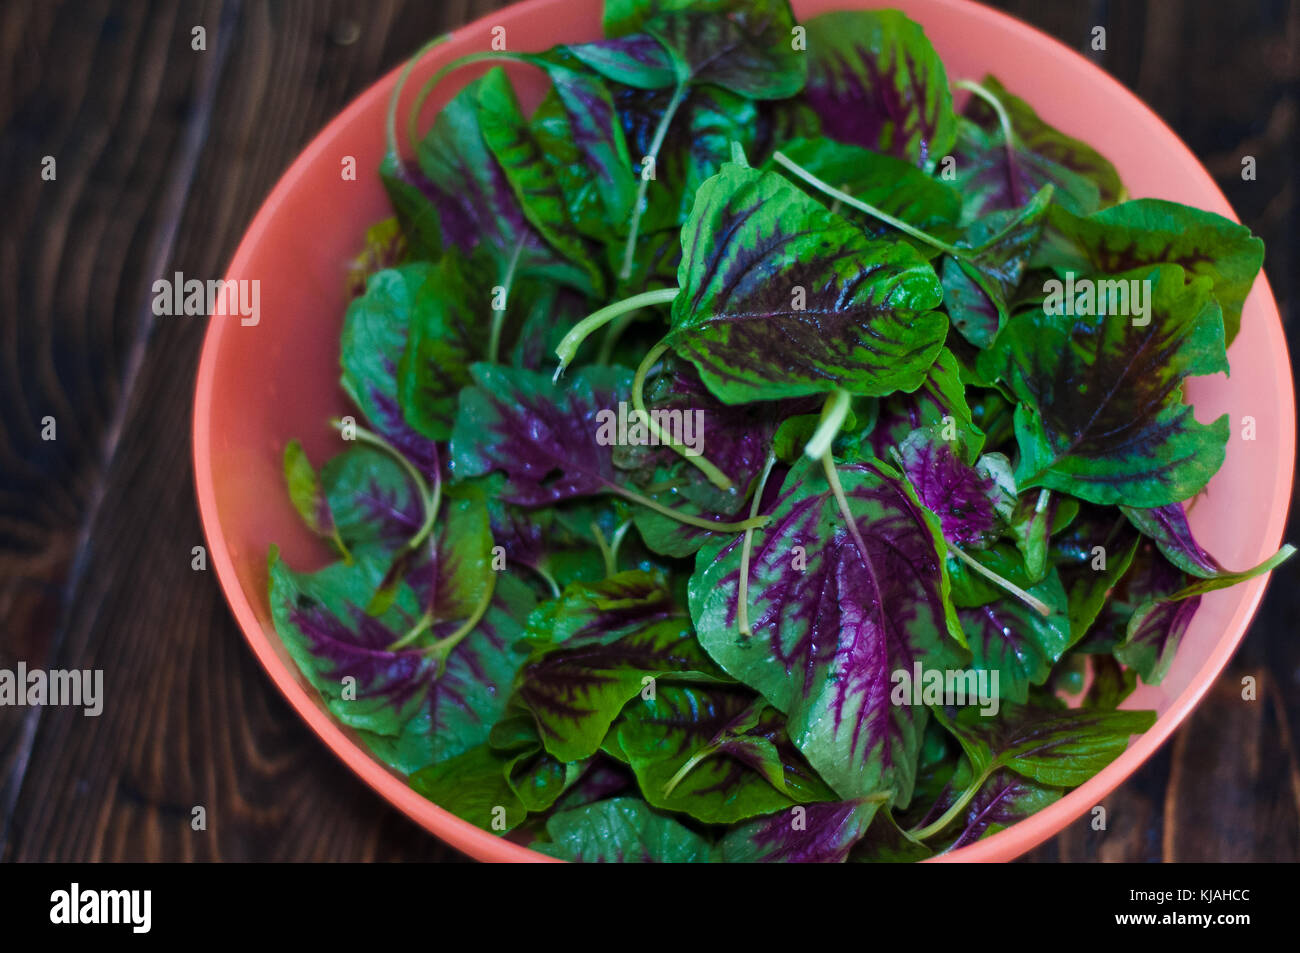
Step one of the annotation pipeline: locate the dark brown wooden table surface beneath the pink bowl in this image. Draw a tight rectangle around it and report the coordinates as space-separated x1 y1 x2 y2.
0 0 1300 861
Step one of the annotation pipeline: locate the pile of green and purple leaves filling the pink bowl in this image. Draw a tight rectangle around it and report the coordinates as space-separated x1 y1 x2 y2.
270 0 1291 861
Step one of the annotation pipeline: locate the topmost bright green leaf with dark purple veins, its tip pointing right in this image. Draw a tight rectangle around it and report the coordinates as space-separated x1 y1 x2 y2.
668 164 946 403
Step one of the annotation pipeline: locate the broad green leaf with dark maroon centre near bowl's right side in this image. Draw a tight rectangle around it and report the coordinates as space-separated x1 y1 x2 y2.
980 265 1229 506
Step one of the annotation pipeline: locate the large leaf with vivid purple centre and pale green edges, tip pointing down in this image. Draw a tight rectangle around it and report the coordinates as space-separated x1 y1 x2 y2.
690 462 965 803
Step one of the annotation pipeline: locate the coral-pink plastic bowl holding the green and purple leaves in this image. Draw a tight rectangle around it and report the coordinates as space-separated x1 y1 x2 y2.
194 0 1295 861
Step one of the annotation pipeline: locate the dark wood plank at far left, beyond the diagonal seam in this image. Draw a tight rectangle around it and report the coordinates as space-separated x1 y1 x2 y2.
0 4 228 845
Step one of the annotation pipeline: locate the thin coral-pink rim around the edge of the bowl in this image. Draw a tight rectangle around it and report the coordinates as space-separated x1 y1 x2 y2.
191 0 1296 862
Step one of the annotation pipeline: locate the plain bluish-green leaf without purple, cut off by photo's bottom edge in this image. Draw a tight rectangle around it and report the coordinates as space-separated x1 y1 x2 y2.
536 797 712 863
